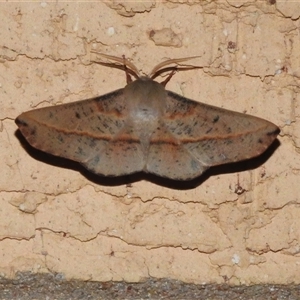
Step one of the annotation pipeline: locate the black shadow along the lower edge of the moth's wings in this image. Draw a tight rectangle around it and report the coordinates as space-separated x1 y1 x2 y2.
16 130 280 190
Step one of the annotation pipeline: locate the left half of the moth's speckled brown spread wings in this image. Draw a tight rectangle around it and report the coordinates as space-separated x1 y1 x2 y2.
16 89 144 176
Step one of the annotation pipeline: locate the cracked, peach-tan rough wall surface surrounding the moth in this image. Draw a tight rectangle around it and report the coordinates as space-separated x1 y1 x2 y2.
0 0 300 284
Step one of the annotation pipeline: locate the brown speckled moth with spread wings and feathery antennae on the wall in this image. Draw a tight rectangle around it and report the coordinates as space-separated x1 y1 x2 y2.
16 54 280 180
